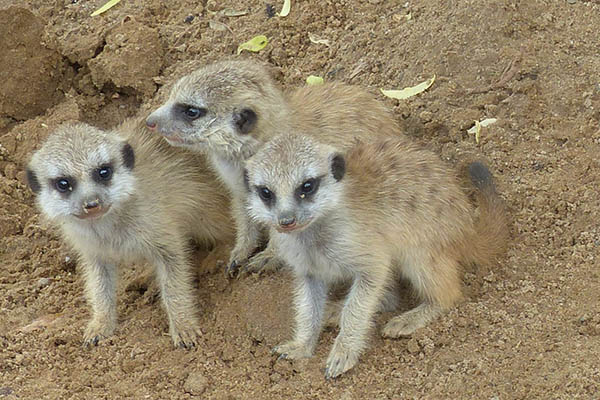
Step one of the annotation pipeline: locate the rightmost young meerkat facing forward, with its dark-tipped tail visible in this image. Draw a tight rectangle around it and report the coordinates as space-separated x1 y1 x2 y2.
247 134 508 378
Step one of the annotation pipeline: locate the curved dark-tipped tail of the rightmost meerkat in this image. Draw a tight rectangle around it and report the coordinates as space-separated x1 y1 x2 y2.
466 161 509 264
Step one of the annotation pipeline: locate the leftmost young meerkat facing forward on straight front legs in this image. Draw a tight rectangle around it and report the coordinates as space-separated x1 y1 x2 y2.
26 119 235 348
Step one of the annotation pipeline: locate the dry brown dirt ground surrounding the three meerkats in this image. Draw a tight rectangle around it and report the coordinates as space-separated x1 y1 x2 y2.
0 0 600 399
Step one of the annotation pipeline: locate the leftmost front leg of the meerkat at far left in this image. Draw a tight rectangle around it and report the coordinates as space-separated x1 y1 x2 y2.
83 260 117 346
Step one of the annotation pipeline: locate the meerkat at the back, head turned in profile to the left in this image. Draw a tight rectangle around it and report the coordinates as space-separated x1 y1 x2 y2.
146 61 406 275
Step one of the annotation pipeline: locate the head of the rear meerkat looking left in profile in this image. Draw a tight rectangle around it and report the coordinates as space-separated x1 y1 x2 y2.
146 61 284 158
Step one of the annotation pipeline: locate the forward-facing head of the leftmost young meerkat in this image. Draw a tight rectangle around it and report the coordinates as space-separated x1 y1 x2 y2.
27 123 135 221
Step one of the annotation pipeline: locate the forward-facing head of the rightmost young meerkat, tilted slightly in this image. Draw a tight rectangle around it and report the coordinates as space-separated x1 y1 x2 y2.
245 134 346 233
